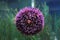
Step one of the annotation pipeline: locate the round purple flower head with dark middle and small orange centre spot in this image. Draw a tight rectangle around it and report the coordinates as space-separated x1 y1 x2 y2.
16 7 44 35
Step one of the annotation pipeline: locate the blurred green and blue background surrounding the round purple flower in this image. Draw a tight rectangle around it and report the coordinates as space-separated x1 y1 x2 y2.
0 0 60 40
